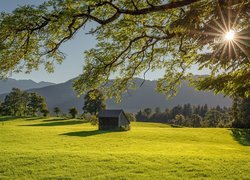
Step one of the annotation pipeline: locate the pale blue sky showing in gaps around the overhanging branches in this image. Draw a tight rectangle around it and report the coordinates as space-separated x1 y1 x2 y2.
0 0 208 83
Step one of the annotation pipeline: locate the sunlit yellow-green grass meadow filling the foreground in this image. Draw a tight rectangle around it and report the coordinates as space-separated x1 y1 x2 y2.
0 118 250 179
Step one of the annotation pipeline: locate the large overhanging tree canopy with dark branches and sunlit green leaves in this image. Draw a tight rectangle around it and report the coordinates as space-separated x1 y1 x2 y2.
0 0 250 97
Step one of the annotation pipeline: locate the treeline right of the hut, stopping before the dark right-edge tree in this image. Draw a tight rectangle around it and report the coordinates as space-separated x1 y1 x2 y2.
136 104 234 127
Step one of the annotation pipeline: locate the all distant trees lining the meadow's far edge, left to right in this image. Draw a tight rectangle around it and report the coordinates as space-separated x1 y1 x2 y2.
0 88 250 128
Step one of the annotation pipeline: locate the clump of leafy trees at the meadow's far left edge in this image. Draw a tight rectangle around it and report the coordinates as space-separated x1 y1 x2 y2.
0 88 49 116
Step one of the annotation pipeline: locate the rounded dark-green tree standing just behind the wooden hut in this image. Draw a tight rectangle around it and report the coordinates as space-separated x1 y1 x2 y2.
82 89 106 115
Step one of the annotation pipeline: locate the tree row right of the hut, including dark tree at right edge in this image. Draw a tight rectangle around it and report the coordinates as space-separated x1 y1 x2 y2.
136 99 250 128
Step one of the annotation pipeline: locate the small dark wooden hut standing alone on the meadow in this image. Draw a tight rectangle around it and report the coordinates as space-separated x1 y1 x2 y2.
98 109 130 130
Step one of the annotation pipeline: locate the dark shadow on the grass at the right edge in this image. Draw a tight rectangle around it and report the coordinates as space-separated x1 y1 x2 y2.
232 129 250 146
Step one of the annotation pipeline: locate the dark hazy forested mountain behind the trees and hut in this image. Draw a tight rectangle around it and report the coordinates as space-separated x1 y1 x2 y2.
0 79 231 112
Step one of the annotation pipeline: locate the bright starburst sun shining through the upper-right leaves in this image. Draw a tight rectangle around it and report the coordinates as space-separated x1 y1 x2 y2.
193 0 250 59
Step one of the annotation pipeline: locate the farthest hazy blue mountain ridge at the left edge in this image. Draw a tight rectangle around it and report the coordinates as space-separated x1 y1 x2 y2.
0 78 54 94
